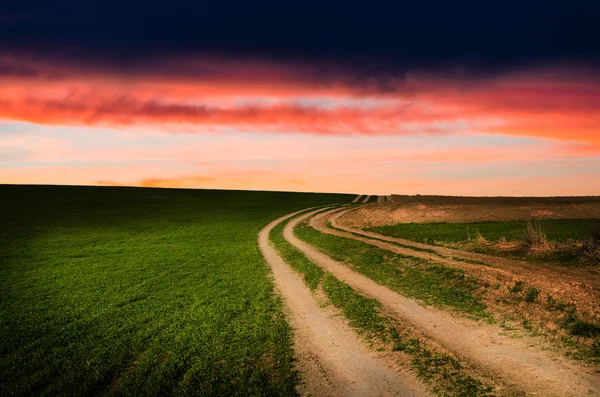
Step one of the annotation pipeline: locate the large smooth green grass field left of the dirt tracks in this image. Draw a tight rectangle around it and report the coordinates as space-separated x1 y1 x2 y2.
0 186 352 395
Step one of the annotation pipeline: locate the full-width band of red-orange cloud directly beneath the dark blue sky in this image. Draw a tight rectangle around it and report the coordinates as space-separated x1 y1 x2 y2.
0 56 600 150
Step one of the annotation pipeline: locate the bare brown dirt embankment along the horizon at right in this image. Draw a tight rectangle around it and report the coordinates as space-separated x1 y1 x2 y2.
342 195 600 228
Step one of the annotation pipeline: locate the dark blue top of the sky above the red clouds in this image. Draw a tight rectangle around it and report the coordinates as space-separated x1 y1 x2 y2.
0 0 600 75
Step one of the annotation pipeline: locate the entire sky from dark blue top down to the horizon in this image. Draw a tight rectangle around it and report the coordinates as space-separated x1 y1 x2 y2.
0 0 600 196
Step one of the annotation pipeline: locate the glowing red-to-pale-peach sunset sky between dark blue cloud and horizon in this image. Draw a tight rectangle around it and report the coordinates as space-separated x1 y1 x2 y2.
0 3 600 195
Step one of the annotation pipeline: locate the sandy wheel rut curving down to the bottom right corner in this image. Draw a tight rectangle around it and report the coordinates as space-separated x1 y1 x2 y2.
284 207 600 396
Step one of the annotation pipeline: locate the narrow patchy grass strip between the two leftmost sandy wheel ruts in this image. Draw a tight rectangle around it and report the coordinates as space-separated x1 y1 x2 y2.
269 213 491 397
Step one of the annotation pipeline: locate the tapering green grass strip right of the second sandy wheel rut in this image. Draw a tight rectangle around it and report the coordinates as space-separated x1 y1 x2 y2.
295 222 489 318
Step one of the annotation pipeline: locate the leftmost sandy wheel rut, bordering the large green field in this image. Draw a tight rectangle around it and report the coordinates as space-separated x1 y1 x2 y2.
258 209 432 396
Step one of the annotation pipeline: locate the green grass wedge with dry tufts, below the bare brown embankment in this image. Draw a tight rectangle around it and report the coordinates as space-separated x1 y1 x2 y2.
367 219 600 264
